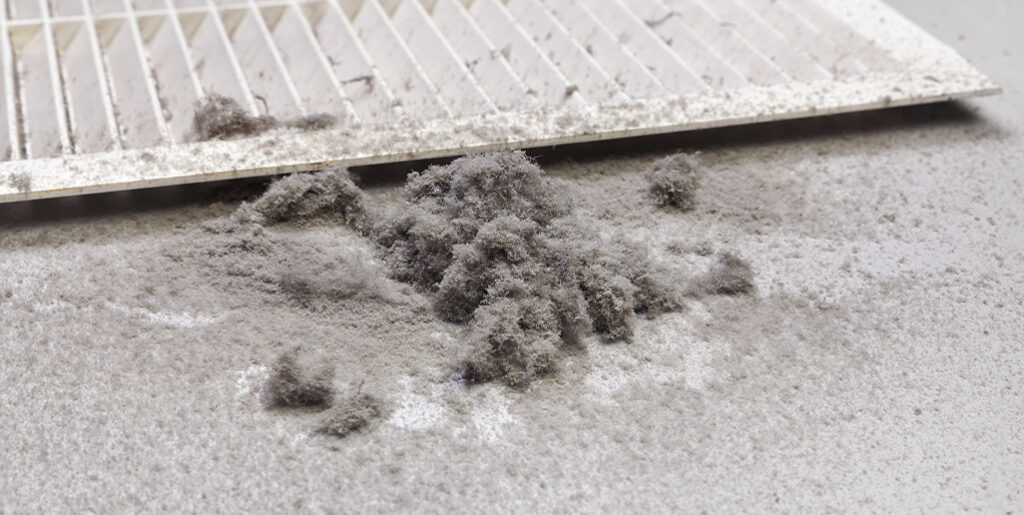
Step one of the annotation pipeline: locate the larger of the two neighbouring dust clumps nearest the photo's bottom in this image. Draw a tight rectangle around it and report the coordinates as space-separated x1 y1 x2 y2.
260 349 334 410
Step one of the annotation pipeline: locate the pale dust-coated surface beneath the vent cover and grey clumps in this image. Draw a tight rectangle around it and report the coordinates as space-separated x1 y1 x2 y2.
0 0 1024 513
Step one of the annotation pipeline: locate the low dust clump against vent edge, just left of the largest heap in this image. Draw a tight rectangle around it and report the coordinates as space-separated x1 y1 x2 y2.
236 166 369 231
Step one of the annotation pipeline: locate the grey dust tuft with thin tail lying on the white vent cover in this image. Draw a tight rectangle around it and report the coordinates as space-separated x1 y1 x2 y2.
193 94 338 141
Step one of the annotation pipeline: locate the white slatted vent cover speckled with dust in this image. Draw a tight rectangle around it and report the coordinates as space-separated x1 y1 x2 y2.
0 0 998 202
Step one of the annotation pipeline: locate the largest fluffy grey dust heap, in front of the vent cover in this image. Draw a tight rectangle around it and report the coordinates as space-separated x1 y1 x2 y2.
373 152 680 387
